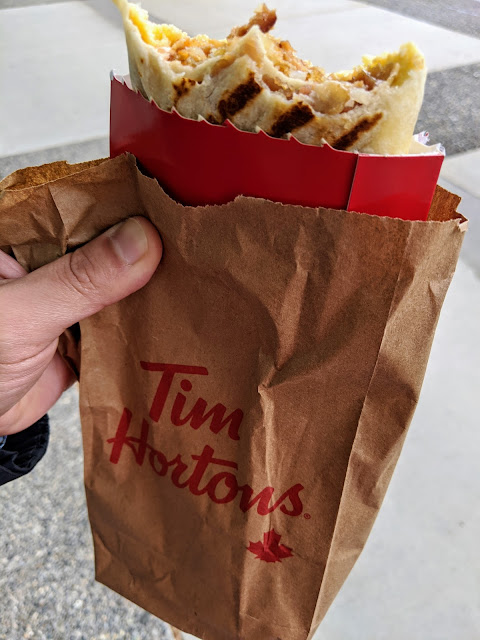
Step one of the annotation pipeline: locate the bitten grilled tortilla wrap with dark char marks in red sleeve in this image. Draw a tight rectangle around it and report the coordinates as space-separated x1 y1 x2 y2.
114 0 426 154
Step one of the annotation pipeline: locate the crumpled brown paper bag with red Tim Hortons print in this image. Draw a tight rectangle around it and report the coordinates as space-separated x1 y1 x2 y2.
0 156 466 640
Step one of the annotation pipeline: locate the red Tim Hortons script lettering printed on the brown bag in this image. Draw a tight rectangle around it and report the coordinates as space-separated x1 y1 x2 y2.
107 361 307 559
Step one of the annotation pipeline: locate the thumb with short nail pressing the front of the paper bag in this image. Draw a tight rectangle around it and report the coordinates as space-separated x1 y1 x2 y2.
0 217 162 344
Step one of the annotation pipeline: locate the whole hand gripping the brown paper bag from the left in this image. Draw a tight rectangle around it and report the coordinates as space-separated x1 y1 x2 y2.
0 217 162 436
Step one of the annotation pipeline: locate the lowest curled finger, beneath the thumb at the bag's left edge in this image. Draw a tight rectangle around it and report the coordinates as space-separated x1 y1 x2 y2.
0 351 76 435
